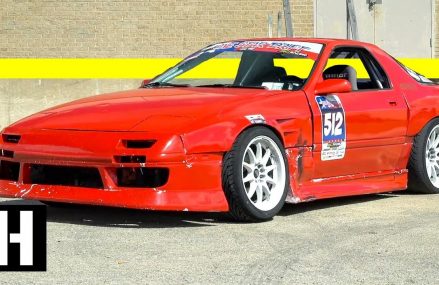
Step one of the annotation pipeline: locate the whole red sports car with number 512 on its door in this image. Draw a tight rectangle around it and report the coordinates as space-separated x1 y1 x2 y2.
0 38 439 221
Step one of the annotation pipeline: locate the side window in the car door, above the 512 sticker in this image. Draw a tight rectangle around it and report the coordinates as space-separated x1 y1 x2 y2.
323 47 390 91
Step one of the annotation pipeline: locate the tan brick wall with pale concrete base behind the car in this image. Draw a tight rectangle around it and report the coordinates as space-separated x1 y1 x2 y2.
0 0 439 129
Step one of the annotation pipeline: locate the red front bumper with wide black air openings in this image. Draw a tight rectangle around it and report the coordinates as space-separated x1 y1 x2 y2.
0 130 228 211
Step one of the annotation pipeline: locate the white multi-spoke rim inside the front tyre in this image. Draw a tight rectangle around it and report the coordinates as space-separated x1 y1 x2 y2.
242 136 286 211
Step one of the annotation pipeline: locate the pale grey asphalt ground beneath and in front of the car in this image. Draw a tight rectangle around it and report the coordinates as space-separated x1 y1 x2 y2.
0 192 439 284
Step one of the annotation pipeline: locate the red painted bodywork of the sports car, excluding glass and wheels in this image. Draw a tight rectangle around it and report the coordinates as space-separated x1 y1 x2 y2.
0 38 439 211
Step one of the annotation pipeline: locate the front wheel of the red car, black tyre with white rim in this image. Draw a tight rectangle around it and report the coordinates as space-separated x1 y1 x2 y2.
222 127 288 221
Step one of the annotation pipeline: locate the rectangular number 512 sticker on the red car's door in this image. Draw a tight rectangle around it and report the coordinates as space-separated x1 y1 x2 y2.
316 95 346 161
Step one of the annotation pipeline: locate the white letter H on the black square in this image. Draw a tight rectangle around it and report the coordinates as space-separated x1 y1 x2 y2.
0 211 33 266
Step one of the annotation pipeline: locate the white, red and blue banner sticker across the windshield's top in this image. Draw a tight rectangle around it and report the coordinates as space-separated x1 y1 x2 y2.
204 41 322 60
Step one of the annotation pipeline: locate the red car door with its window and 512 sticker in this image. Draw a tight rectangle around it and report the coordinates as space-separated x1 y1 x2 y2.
310 48 408 179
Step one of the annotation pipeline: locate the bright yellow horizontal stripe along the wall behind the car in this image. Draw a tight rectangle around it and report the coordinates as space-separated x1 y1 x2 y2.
0 58 439 79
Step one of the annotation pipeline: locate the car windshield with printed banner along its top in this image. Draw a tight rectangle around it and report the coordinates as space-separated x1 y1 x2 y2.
150 41 323 90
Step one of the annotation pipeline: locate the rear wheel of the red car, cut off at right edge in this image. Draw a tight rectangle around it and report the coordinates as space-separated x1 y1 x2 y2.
409 119 439 194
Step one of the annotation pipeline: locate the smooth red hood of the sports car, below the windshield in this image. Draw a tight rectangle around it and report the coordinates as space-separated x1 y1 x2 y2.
8 88 267 132
